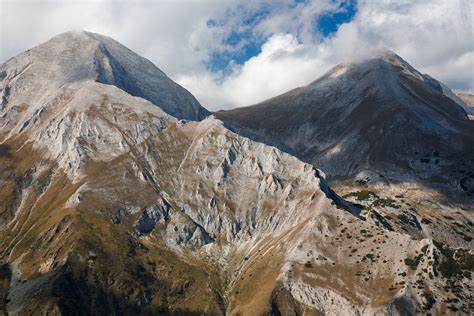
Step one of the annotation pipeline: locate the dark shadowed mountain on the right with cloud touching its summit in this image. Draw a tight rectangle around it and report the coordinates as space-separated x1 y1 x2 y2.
215 50 474 195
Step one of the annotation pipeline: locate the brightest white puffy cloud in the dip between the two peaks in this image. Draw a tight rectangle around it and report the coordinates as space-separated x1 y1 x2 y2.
176 34 328 110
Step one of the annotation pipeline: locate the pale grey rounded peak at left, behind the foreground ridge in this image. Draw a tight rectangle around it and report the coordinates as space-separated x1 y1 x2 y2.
0 31 209 120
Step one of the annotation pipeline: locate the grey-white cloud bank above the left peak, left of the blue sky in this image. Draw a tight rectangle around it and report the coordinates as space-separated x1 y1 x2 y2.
0 0 232 75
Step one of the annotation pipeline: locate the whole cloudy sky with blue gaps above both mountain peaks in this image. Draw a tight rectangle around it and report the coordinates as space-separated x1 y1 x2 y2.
0 0 474 110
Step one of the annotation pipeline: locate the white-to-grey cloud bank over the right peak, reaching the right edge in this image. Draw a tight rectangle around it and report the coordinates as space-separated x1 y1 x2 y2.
177 1 474 109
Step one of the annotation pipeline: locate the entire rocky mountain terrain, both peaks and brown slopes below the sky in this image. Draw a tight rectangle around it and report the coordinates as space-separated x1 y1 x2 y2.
0 31 474 315
